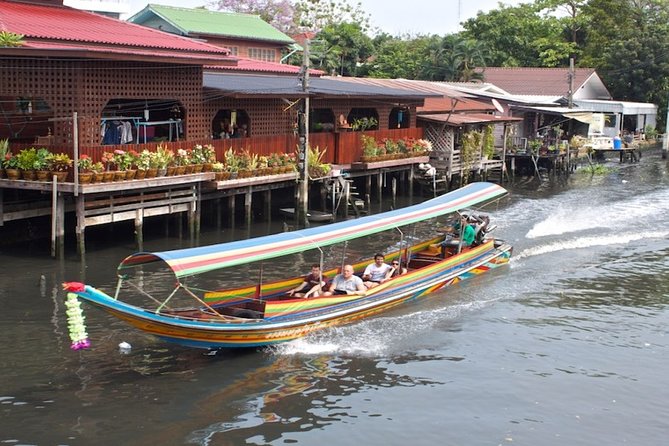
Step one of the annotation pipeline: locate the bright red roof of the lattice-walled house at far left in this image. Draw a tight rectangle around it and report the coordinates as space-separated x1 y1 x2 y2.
0 0 228 59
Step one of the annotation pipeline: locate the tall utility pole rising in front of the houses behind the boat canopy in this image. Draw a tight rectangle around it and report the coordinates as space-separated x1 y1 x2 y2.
295 39 309 227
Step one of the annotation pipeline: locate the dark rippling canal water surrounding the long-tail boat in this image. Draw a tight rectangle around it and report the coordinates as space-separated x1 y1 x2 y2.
0 151 669 446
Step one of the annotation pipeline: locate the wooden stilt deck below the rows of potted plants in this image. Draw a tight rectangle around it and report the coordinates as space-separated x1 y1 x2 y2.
0 157 428 257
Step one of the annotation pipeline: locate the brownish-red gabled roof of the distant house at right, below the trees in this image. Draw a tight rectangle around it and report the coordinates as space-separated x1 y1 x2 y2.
483 67 595 96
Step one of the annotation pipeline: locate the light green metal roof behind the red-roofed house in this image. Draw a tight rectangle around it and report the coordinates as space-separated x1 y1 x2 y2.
128 4 294 44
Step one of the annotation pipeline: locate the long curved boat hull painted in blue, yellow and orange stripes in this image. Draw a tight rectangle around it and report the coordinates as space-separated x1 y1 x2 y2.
75 241 512 349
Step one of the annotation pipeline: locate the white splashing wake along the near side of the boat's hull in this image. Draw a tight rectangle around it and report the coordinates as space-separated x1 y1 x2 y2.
272 296 497 357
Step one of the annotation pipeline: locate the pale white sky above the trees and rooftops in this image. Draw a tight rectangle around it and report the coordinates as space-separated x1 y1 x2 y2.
129 0 529 35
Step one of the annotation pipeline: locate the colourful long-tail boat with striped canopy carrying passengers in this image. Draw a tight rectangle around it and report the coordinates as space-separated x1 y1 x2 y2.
66 182 512 349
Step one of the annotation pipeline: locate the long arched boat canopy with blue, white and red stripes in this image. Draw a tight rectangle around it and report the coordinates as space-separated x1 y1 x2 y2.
118 182 507 278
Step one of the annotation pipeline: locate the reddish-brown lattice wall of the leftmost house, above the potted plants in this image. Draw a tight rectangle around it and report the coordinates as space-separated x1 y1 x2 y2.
0 58 210 145
